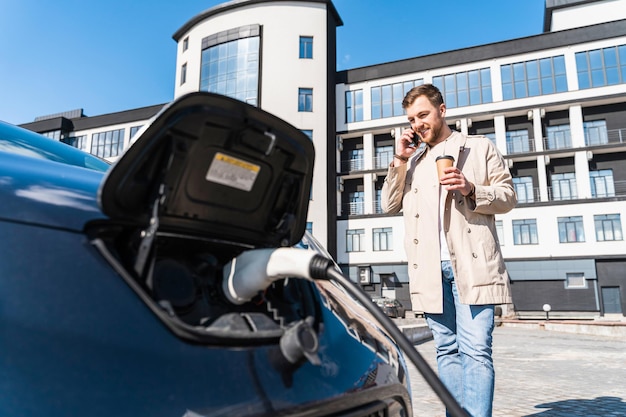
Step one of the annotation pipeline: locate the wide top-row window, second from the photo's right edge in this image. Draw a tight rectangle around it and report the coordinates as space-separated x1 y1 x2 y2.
500 55 567 100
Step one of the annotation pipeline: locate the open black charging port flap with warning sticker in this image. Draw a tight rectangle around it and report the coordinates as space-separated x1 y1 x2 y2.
98 92 314 247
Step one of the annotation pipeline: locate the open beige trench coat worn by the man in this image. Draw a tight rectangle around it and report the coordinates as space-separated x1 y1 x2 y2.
381 132 517 314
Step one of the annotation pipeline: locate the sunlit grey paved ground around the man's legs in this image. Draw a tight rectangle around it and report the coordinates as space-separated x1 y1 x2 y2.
409 327 626 417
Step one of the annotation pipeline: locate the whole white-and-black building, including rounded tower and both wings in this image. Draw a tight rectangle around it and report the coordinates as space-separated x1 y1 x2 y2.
24 0 626 318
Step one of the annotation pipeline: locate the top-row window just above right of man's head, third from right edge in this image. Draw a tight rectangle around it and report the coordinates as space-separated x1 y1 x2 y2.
433 68 493 108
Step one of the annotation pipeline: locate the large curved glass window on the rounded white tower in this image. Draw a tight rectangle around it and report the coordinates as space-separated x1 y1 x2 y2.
200 25 261 106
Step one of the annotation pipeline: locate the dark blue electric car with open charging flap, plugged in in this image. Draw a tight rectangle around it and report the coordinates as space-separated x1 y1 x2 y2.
0 93 412 417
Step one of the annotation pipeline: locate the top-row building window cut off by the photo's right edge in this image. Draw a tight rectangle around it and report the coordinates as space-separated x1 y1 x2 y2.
576 45 626 89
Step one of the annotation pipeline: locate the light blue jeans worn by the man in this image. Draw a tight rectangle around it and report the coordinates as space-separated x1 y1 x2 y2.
426 261 495 417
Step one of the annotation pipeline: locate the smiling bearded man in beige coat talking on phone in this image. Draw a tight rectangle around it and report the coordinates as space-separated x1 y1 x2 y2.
382 84 517 417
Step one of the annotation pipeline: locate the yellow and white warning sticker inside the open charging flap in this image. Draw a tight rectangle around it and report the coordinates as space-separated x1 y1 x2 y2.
206 152 261 191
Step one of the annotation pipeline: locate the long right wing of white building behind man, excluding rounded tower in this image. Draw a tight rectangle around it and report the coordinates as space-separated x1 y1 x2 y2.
337 1 626 317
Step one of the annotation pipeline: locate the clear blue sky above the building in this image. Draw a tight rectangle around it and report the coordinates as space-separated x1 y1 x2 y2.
0 0 544 124
